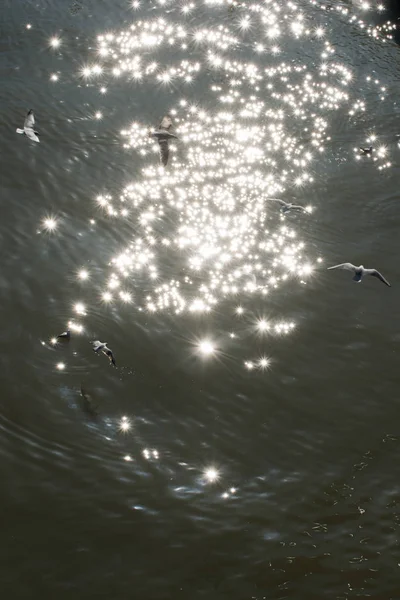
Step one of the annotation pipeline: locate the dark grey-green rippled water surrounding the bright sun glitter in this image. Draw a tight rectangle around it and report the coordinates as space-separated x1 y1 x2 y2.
0 0 400 600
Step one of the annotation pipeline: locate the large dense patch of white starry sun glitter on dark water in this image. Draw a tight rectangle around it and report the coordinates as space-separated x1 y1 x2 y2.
78 3 362 313
